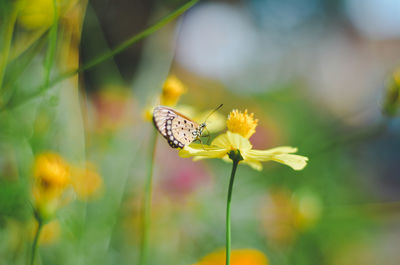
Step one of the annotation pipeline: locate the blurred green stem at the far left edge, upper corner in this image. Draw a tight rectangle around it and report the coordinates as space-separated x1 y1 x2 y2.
0 3 18 106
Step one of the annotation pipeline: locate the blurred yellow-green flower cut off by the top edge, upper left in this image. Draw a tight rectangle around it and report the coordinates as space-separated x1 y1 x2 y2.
18 0 59 30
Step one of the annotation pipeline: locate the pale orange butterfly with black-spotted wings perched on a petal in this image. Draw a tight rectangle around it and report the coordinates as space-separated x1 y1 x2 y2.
153 104 222 148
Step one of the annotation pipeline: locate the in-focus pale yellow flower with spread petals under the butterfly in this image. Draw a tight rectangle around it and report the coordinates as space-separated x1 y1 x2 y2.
179 108 308 170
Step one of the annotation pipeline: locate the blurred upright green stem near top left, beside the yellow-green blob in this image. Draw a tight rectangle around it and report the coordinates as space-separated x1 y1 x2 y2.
41 0 58 91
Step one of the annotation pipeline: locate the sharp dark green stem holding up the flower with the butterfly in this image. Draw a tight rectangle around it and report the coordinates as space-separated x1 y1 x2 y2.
225 151 243 265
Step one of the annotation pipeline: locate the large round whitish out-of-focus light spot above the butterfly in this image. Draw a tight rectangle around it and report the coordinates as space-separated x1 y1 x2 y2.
176 3 256 80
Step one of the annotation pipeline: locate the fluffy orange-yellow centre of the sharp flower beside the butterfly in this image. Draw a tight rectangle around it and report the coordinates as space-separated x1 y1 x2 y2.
226 109 258 139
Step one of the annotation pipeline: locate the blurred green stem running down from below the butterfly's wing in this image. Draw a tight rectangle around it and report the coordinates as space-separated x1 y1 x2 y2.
139 130 157 265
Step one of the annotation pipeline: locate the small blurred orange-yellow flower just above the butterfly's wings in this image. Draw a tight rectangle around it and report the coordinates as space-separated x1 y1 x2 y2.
160 75 186 106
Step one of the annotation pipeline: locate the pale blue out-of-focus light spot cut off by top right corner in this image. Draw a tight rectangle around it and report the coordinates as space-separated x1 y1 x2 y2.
345 0 400 39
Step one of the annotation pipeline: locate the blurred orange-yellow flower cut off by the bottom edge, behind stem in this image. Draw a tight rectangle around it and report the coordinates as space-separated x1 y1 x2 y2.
193 249 268 265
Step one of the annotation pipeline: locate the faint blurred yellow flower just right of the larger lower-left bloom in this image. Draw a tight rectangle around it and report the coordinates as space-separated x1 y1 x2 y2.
71 163 103 200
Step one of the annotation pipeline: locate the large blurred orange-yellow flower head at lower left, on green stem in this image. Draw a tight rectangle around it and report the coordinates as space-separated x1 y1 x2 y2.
32 153 70 218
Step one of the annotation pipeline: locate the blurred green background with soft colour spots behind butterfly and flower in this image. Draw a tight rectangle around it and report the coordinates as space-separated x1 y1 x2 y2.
0 0 400 265
